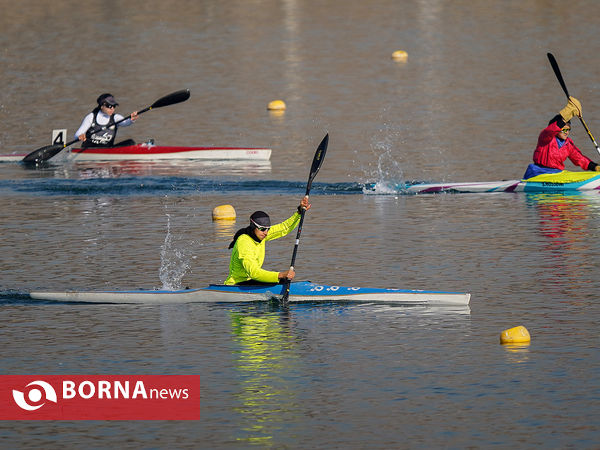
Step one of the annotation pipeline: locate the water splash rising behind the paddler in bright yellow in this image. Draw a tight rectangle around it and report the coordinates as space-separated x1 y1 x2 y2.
159 213 191 291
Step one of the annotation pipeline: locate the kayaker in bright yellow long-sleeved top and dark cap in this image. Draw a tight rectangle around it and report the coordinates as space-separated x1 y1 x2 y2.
225 197 310 285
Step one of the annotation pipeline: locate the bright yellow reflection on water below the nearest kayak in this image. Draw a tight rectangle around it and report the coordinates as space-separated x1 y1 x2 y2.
230 312 300 446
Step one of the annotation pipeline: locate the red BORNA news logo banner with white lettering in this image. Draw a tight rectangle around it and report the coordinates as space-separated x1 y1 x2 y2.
0 375 200 420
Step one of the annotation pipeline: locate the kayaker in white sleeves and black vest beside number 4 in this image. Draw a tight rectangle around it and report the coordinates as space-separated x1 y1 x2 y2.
75 93 138 148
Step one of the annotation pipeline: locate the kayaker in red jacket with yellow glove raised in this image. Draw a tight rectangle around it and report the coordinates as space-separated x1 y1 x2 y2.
523 97 600 179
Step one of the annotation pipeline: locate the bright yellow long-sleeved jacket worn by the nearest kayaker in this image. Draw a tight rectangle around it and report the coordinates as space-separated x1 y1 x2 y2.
225 212 300 285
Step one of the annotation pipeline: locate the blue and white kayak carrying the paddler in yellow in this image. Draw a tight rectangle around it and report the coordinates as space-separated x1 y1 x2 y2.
29 281 471 306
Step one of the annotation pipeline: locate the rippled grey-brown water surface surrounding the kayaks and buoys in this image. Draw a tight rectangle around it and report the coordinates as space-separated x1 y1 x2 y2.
0 0 600 449
